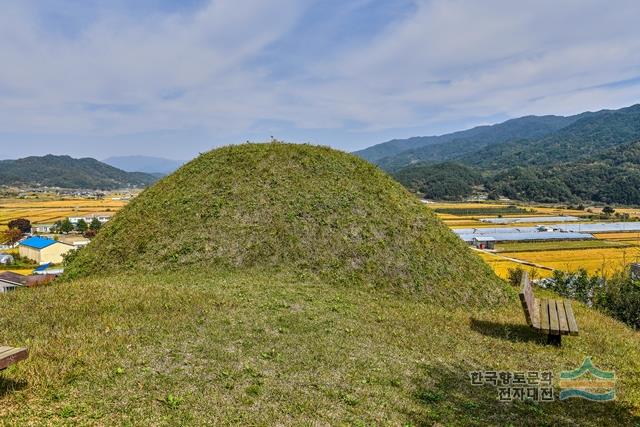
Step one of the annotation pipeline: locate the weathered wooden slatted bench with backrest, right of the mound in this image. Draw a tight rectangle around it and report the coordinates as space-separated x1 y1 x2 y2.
520 272 578 345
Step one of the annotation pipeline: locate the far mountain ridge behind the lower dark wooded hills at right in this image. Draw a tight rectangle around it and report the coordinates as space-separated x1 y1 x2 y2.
355 104 640 171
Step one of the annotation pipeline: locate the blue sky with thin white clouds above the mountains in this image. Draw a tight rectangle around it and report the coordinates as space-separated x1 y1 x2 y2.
0 0 640 159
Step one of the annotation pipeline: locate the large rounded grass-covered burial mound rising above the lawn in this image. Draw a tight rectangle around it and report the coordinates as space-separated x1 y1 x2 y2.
62 143 508 303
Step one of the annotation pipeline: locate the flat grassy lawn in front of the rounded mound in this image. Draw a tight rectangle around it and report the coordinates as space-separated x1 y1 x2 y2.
0 273 640 426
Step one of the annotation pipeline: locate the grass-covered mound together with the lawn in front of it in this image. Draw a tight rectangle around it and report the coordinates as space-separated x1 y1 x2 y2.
0 144 640 426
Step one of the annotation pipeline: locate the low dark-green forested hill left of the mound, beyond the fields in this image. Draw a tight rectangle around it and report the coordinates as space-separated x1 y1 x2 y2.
0 154 156 190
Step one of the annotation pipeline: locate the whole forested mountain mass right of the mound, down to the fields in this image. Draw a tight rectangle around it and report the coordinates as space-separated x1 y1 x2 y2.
355 105 640 204
